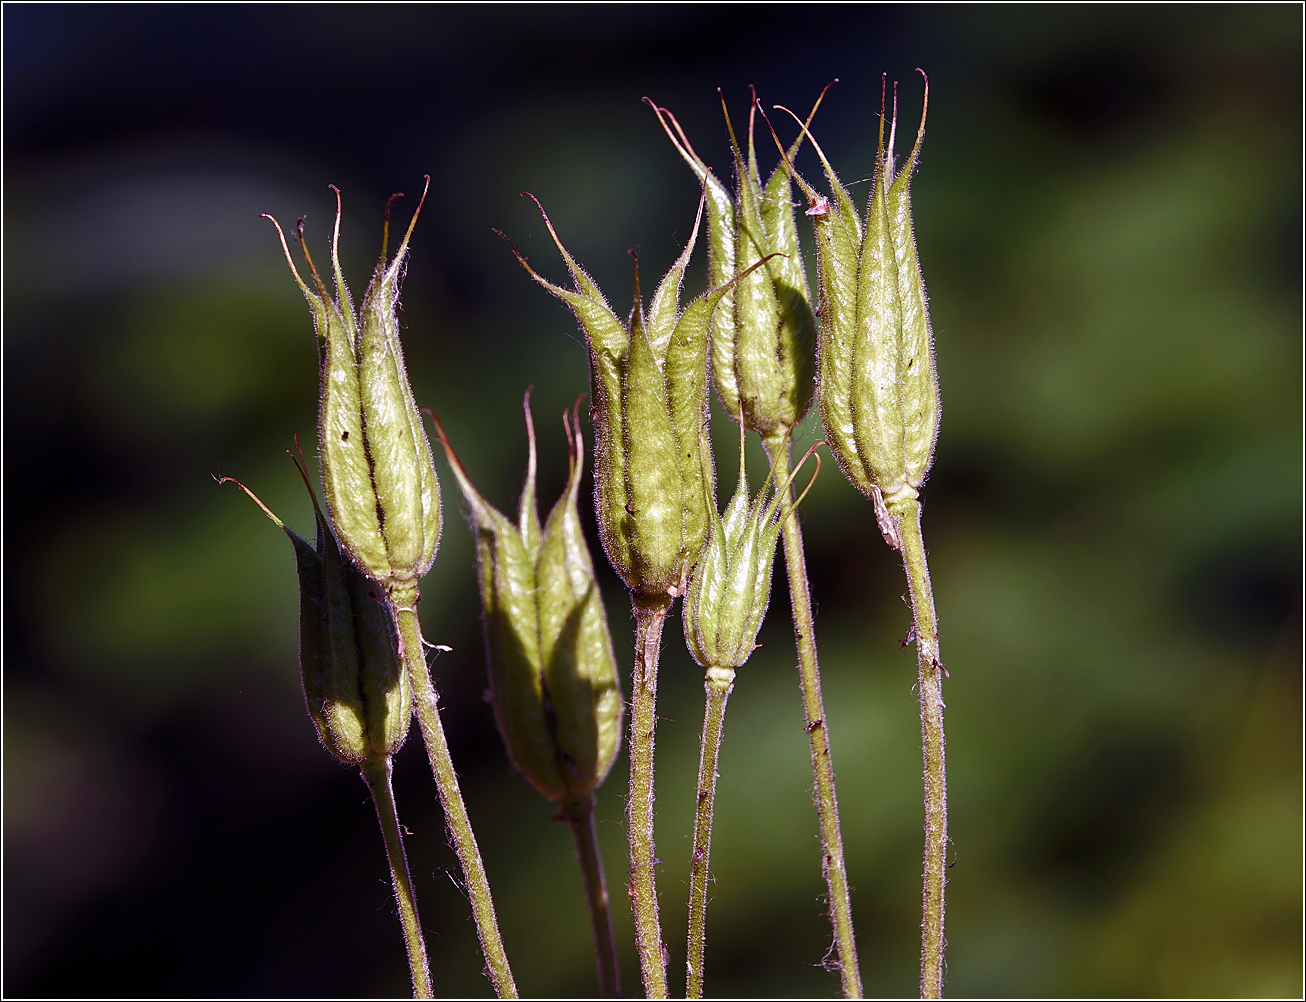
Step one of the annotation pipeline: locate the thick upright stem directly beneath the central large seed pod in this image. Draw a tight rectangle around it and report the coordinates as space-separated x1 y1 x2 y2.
627 592 671 998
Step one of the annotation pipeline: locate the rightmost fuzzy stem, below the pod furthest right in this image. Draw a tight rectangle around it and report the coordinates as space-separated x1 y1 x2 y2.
888 498 948 998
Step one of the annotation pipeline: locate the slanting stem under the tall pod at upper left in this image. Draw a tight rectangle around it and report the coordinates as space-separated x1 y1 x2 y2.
393 601 517 998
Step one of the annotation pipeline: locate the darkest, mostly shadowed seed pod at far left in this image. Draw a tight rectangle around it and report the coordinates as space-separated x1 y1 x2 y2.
219 469 413 766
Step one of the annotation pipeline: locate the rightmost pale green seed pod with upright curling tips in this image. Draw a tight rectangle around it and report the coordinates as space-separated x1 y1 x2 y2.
773 73 939 522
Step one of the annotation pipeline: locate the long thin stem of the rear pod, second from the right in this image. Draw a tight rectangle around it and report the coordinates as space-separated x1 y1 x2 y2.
763 431 862 998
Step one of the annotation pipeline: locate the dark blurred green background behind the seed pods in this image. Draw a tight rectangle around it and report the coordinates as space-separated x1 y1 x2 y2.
4 5 1302 997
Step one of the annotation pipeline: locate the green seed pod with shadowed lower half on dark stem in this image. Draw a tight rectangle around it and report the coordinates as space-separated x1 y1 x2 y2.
436 391 623 803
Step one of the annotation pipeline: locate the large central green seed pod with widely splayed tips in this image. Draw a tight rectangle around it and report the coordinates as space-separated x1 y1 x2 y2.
505 196 727 597
